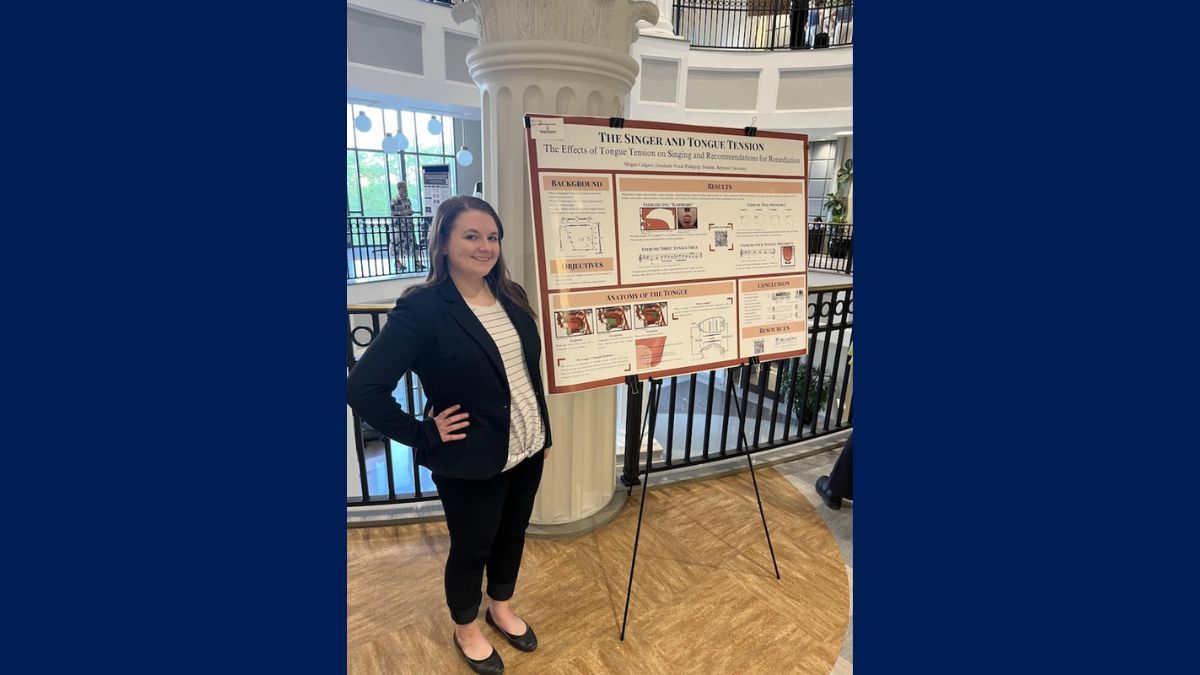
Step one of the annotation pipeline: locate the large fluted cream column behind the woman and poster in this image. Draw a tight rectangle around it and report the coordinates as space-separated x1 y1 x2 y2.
452 0 658 525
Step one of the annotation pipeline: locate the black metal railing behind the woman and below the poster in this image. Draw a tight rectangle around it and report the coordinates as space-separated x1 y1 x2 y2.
346 281 854 507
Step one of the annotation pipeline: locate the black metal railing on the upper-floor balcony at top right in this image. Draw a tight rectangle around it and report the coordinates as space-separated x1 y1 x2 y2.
672 0 854 49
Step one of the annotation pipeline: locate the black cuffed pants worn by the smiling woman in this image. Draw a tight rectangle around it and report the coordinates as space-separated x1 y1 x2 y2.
433 453 545 625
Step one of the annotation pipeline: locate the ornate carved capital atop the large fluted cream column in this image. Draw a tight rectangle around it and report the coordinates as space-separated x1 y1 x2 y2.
450 0 659 54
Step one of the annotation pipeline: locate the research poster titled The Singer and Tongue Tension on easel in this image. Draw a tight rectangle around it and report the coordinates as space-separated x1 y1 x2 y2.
526 114 808 394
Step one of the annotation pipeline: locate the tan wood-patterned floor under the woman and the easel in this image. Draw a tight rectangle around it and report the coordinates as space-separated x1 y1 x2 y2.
347 441 853 675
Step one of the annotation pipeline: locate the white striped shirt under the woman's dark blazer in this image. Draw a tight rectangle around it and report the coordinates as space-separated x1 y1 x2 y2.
467 301 546 471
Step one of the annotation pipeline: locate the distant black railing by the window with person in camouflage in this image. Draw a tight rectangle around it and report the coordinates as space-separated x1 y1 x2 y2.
346 216 431 281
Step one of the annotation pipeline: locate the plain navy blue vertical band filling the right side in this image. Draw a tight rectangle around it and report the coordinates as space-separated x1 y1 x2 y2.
854 4 1195 674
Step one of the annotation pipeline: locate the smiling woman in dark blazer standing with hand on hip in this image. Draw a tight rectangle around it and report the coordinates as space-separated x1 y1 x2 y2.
348 196 551 673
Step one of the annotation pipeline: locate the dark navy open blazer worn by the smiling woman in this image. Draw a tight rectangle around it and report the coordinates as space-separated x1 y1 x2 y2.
347 280 551 479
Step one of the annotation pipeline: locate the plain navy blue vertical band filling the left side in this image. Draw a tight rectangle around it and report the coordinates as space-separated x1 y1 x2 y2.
4 4 346 673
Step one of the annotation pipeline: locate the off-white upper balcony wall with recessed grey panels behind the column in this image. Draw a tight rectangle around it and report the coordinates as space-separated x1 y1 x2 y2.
347 0 854 138
